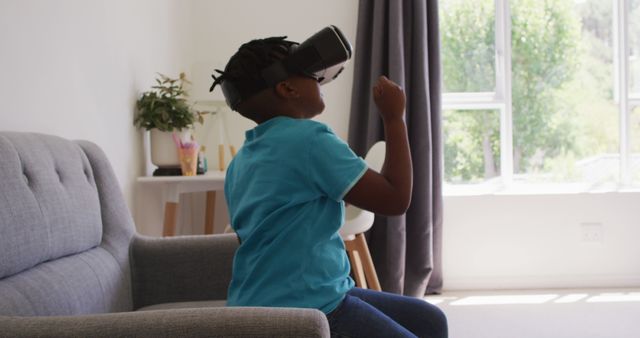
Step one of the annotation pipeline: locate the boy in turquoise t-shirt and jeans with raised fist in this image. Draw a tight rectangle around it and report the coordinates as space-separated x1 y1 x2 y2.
212 32 447 337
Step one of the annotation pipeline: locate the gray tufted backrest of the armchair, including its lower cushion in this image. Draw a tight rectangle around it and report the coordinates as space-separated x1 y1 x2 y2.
0 132 134 316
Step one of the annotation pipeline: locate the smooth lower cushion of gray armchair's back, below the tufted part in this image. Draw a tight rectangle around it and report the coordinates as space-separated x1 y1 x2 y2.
0 247 131 316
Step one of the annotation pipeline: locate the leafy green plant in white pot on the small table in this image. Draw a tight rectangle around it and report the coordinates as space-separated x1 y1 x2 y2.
133 73 205 176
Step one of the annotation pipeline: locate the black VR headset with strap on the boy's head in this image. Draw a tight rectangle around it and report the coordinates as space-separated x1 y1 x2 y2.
209 26 352 110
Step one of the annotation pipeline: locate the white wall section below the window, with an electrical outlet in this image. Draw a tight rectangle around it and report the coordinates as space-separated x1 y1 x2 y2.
443 192 640 290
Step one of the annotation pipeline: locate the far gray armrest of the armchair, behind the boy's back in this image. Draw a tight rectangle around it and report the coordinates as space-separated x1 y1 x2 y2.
130 234 238 309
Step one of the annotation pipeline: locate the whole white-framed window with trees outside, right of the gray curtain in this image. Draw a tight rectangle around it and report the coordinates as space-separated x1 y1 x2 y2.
440 0 640 193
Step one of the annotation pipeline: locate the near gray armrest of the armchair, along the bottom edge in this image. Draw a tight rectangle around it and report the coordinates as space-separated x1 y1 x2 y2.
0 307 329 338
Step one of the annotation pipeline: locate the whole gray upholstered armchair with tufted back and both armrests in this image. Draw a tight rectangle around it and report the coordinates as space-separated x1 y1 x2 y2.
0 132 329 337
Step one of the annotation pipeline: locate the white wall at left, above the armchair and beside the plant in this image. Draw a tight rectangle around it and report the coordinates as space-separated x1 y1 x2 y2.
0 0 190 206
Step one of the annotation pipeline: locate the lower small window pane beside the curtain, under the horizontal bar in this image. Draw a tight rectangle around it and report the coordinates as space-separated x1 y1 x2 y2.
443 110 500 184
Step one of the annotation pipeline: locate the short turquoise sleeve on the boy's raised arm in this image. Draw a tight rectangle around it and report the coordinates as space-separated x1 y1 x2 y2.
307 126 367 201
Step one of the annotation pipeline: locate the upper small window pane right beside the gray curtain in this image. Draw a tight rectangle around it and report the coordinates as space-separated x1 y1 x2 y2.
439 0 496 93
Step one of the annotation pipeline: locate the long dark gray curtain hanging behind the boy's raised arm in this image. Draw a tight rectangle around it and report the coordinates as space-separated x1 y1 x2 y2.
349 0 442 297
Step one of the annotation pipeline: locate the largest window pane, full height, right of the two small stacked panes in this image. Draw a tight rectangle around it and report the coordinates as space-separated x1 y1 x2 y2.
511 0 619 188
